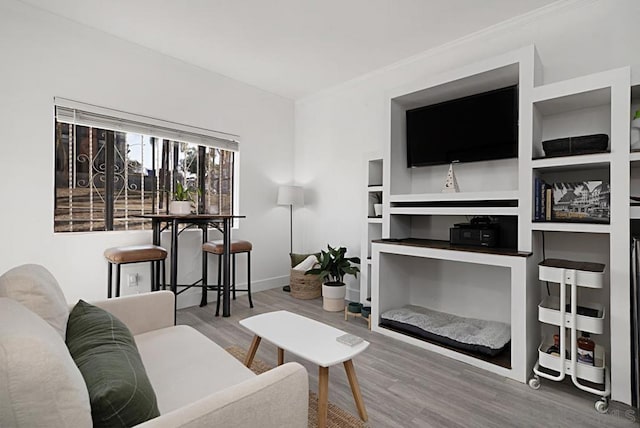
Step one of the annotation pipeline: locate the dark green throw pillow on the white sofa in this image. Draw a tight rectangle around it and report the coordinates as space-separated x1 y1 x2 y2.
66 300 160 427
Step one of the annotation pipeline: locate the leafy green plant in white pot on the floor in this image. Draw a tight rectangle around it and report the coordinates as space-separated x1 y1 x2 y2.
305 245 360 312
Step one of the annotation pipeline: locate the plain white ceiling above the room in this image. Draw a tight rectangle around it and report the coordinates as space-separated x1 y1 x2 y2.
23 0 556 99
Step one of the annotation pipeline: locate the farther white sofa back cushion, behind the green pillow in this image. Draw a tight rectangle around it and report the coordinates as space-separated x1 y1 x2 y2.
0 264 69 340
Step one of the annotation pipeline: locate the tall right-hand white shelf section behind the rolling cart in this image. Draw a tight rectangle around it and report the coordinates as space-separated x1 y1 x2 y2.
531 68 631 403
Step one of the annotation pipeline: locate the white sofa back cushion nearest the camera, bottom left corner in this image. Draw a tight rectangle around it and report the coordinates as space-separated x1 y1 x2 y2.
0 298 93 427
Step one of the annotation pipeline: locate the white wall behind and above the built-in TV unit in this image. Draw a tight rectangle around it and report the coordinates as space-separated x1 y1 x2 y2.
295 0 640 306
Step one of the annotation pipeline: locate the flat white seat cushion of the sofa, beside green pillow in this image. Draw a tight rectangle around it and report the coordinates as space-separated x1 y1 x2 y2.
134 325 256 412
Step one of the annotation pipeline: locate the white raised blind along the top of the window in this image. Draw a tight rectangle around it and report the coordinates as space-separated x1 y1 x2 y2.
54 97 239 152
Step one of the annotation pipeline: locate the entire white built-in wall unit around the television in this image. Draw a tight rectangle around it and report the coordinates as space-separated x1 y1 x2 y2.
368 46 640 403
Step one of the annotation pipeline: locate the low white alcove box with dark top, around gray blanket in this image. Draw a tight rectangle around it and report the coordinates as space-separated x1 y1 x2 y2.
372 240 529 381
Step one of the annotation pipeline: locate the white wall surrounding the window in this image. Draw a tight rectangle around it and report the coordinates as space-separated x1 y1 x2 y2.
0 0 294 305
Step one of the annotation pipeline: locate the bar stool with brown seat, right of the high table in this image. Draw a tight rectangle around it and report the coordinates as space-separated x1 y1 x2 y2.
200 240 253 316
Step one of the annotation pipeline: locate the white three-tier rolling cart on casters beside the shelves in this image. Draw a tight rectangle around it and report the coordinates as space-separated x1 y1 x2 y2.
529 259 611 413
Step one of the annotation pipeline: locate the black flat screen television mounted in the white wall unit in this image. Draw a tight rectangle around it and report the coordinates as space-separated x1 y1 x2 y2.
406 85 518 168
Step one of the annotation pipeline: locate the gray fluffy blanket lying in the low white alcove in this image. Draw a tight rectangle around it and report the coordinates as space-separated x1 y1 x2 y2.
381 305 511 349
